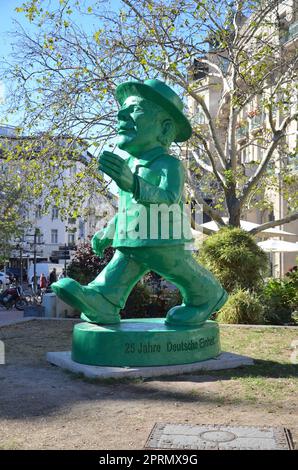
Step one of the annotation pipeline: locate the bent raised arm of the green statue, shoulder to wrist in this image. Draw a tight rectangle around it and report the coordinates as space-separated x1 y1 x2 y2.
134 158 185 204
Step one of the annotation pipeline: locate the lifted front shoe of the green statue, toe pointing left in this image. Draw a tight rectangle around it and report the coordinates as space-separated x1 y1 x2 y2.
51 277 120 324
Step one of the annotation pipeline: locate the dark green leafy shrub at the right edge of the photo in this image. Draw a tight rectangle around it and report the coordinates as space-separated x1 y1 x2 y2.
263 271 298 325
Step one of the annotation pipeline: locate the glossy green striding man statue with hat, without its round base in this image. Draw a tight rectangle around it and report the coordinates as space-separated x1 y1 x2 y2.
51 80 227 363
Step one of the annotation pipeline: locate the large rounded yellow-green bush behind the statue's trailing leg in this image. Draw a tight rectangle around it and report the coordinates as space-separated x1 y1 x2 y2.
196 227 268 292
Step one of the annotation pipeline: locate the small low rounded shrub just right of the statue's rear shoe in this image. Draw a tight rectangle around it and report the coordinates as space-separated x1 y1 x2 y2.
216 289 264 325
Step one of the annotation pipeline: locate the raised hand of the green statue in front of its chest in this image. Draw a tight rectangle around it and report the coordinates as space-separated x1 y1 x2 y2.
98 151 135 192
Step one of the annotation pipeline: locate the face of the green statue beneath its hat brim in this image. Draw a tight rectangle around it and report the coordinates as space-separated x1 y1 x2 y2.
117 96 162 156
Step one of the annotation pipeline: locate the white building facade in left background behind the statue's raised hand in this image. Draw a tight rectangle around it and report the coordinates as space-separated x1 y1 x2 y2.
0 126 117 268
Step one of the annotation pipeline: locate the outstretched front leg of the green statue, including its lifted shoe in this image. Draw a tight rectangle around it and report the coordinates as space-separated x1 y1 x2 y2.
51 250 147 324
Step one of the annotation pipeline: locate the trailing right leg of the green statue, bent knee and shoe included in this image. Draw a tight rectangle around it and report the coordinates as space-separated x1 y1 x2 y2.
140 245 228 325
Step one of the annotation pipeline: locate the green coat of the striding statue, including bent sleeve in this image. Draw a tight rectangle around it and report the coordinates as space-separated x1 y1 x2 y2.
111 147 192 248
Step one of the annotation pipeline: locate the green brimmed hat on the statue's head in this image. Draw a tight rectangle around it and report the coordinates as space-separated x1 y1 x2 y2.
116 80 192 142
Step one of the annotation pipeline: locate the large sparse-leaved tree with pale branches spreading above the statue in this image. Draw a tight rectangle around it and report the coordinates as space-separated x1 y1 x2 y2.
2 0 298 233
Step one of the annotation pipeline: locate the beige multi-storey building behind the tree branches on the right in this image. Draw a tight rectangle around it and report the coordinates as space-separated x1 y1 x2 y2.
188 0 298 277
